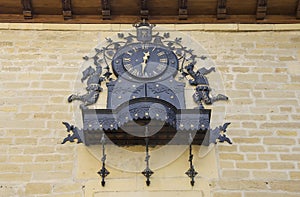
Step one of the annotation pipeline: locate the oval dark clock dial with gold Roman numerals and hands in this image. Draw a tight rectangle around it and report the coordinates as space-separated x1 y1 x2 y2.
112 43 178 79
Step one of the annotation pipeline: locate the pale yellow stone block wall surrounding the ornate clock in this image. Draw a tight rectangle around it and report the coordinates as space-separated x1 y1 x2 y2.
0 24 300 197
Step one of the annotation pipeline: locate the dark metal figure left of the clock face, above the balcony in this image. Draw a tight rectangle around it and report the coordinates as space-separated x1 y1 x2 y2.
68 65 105 109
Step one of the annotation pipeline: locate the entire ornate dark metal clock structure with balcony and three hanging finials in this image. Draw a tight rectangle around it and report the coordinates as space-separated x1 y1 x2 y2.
62 20 232 186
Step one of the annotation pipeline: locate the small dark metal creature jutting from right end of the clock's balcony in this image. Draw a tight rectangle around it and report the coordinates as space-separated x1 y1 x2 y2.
209 122 232 144
